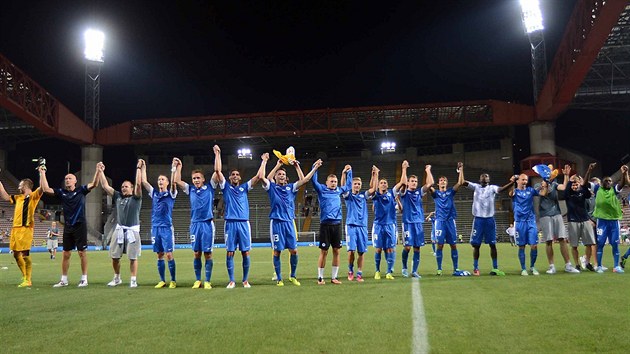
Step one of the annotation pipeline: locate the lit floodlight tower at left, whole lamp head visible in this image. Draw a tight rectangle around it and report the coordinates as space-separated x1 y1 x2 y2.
83 29 105 131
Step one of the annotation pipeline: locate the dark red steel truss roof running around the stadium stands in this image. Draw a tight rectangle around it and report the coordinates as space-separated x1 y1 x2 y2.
0 0 630 147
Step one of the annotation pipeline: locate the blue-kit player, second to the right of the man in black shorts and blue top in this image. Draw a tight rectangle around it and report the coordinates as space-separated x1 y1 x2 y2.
368 166 401 280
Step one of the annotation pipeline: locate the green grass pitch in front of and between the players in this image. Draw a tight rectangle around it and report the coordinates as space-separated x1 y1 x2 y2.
0 244 630 353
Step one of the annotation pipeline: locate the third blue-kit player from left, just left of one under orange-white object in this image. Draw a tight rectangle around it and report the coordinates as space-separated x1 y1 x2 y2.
217 153 269 289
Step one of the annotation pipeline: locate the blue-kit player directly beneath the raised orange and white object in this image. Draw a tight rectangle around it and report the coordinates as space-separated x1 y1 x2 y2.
258 156 322 286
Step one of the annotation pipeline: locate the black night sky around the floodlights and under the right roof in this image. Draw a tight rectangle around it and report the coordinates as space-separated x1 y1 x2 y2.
0 0 629 183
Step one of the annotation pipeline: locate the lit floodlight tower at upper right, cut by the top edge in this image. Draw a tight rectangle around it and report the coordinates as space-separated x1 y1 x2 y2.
520 0 547 103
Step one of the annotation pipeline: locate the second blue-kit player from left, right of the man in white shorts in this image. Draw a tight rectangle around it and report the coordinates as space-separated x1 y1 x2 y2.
173 145 222 290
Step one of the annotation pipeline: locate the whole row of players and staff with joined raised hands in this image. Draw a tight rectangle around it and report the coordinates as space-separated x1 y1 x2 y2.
0 145 630 289
